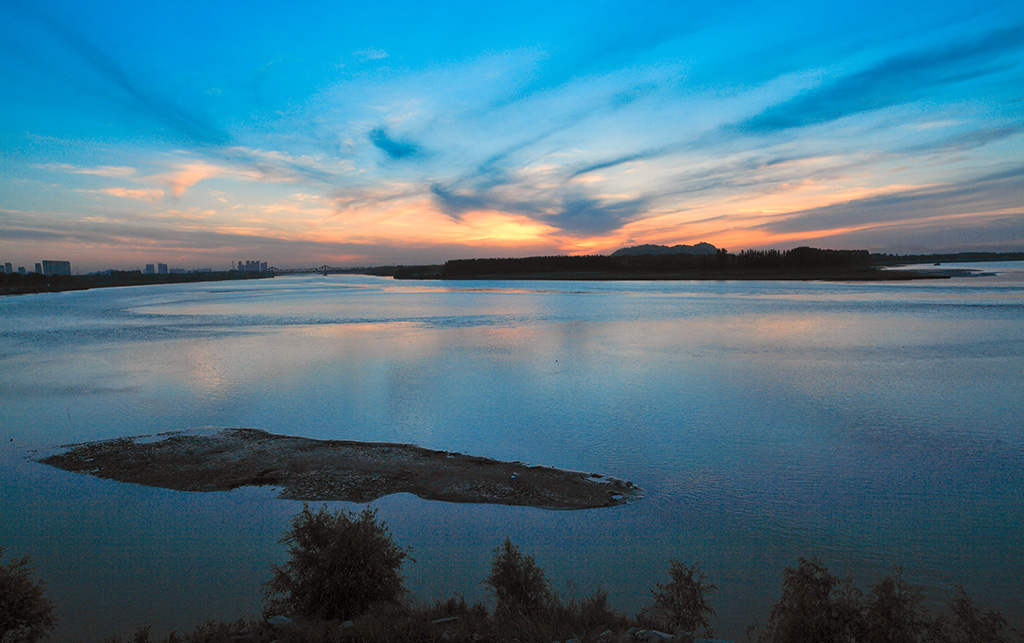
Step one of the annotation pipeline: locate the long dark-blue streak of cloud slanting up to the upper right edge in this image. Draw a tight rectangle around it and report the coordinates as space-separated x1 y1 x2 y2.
735 26 1024 133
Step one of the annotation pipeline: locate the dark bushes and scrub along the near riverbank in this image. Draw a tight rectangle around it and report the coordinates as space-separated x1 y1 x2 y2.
0 507 1024 643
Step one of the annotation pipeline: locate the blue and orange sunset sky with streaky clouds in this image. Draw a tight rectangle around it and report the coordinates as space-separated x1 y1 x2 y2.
0 0 1024 272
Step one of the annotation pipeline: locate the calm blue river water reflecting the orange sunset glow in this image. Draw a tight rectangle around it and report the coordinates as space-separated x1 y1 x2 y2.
0 262 1024 640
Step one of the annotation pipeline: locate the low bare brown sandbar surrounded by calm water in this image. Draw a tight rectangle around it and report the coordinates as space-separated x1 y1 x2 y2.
39 428 640 509
